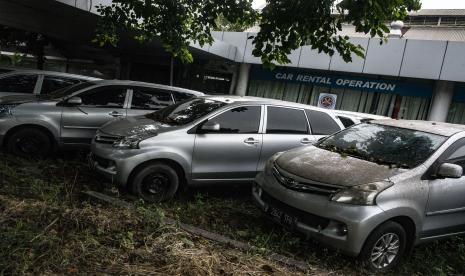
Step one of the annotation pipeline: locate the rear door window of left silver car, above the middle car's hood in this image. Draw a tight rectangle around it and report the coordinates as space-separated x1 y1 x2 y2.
131 87 173 110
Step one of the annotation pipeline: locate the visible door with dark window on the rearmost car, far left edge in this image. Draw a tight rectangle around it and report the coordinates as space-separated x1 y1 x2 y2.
0 74 40 96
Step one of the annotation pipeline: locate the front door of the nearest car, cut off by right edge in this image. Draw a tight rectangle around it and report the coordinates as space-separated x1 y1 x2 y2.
423 138 465 236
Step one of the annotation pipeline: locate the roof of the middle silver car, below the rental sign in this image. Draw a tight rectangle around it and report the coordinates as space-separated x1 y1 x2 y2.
199 95 334 112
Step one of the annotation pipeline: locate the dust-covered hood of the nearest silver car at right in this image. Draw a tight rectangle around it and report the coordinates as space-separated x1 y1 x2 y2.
276 146 405 186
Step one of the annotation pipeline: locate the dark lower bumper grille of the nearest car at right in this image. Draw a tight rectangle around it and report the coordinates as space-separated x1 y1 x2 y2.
261 191 329 229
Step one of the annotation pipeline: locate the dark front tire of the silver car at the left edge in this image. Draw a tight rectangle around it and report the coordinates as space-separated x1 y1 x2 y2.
6 128 53 158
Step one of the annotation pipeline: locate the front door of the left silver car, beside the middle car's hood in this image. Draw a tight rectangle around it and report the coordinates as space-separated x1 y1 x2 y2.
61 86 128 144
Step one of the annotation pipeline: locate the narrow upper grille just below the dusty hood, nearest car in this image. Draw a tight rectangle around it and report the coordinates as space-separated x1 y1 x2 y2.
273 164 343 196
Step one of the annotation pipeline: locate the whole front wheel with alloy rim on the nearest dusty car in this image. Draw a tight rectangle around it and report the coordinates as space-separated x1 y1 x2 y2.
360 221 407 272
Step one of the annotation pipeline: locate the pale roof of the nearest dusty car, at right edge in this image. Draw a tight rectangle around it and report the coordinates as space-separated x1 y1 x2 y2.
369 119 465 137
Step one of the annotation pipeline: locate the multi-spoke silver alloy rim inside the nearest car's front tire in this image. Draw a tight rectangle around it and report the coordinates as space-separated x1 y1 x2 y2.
371 233 400 268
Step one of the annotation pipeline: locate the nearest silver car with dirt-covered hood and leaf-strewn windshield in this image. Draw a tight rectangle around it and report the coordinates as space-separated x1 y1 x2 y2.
253 120 465 271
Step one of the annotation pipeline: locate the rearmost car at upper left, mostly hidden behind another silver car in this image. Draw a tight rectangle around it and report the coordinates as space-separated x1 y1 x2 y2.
0 69 100 97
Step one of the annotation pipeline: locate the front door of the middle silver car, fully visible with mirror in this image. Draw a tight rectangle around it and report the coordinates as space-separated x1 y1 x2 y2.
192 105 262 181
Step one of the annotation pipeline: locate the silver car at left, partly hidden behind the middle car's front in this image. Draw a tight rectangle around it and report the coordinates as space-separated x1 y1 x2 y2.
0 80 203 156
